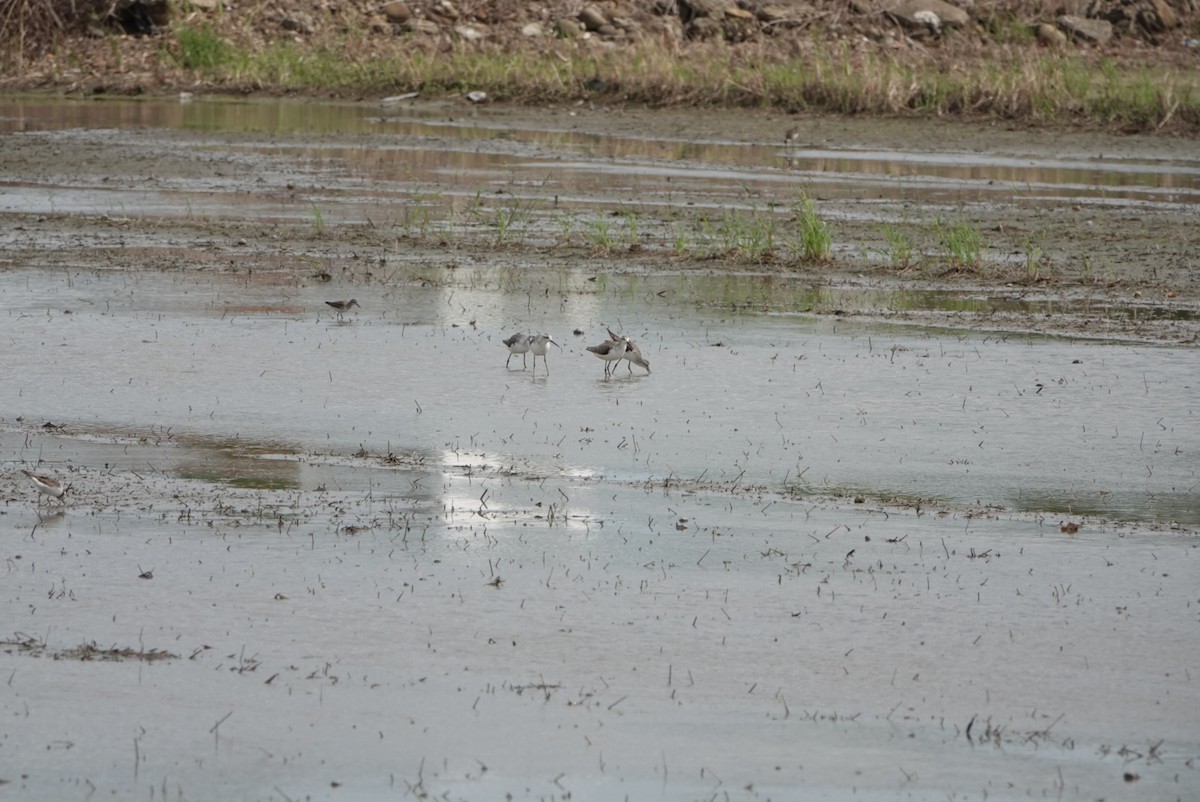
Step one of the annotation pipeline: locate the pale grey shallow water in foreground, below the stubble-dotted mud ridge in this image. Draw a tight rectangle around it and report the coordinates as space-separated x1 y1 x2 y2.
0 473 1200 800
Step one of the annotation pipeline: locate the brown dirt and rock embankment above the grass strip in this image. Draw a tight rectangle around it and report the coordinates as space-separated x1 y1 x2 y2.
7 0 1200 115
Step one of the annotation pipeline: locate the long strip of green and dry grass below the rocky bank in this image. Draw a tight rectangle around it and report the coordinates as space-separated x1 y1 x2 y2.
0 0 1200 131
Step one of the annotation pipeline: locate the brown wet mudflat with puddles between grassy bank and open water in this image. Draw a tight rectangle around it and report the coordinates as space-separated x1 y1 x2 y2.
0 98 1200 342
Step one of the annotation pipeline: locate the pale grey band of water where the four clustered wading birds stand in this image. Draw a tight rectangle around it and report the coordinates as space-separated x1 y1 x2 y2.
0 270 1200 523
